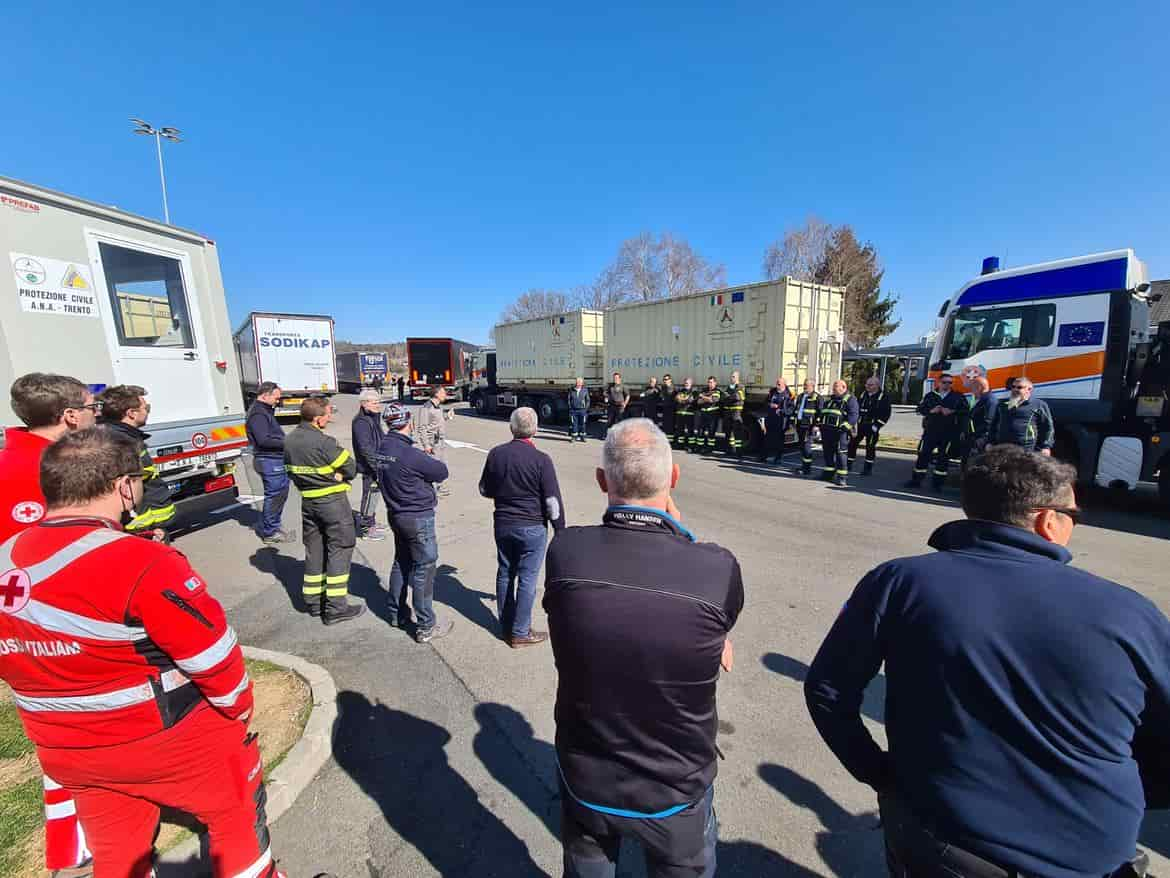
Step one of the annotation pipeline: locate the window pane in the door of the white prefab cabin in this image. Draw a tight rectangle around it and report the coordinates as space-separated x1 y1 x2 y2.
98 242 194 348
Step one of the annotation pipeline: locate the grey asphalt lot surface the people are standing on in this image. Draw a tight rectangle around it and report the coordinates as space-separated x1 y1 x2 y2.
164 397 1170 878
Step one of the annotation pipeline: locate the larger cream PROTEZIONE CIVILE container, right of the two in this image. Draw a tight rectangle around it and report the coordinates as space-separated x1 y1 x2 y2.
604 277 845 444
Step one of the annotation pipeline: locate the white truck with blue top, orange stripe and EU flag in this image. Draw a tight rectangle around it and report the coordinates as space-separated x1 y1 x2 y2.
927 249 1170 508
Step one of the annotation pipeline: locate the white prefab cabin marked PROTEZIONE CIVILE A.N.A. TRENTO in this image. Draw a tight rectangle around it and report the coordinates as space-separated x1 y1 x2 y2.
0 178 247 528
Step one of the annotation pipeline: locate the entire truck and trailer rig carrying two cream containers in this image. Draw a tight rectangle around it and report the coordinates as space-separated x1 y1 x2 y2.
473 277 845 445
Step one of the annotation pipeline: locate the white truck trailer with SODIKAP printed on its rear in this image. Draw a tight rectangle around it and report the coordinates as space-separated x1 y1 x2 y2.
235 311 337 417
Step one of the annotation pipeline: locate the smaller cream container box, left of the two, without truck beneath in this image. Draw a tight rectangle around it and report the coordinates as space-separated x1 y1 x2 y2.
496 310 605 387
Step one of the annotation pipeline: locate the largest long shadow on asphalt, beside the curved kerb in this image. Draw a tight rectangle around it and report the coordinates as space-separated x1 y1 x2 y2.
333 691 545 878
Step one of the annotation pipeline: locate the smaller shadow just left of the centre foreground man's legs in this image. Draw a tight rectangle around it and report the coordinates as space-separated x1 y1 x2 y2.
473 702 560 839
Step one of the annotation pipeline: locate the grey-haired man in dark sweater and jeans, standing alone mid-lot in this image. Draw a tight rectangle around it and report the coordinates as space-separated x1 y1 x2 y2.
480 407 565 650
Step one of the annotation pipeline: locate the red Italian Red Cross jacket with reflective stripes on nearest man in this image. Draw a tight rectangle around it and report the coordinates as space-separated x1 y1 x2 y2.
0 519 252 748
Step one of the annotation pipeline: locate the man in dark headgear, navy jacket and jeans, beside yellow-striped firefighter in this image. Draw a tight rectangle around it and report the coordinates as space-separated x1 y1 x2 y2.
378 403 454 643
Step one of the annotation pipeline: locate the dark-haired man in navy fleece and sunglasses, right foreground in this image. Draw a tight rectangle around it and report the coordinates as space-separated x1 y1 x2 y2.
805 446 1170 878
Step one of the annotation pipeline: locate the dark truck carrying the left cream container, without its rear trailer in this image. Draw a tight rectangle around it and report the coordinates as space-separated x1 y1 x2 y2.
472 309 605 423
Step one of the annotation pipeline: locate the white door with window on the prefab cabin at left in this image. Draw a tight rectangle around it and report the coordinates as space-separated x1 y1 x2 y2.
87 231 219 423
